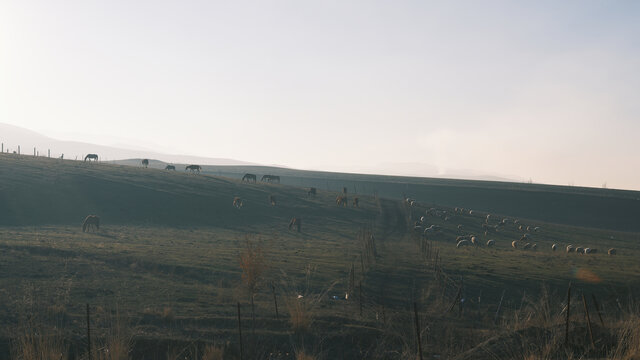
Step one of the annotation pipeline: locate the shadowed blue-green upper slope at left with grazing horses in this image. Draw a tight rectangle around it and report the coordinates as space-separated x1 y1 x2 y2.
0 154 373 227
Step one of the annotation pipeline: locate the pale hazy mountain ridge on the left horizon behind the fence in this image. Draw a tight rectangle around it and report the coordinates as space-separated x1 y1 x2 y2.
0 123 257 166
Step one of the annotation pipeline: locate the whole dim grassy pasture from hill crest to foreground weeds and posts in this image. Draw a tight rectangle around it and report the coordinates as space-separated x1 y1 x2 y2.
0 154 640 359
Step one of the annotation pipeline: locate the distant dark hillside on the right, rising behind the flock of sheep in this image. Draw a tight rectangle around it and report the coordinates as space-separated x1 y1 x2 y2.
118 160 640 231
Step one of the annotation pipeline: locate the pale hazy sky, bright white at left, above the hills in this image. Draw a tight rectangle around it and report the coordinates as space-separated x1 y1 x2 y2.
0 0 640 189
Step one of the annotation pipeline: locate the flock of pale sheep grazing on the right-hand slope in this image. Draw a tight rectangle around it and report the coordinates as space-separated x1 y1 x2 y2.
405 205 618 255
